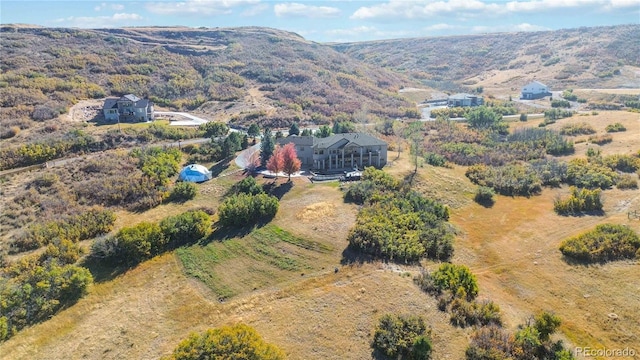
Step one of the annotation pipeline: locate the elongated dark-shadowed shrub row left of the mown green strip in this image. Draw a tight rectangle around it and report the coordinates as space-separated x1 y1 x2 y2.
91 210 211 266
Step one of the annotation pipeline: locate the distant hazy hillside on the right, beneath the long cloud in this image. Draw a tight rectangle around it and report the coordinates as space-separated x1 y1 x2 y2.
333 25 640 90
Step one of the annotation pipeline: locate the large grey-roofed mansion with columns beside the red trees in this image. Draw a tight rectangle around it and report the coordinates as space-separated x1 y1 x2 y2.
277 133 387 172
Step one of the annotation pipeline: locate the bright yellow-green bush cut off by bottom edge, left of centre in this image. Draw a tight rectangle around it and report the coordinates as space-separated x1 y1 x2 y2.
166 324 285 360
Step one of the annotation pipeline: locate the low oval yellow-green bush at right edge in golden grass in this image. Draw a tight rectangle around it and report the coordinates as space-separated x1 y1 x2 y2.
560 224 640 262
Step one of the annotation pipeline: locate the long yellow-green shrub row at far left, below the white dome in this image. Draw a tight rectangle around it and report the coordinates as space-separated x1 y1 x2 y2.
13 208 116 252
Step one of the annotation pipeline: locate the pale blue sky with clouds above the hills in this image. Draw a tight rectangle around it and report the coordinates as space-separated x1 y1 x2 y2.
0 0 640 42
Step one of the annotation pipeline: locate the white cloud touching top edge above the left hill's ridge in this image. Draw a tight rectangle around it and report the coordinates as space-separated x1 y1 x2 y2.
144 0 260 16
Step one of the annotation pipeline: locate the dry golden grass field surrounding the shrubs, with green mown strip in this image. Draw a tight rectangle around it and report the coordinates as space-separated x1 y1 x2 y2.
0 112 640 359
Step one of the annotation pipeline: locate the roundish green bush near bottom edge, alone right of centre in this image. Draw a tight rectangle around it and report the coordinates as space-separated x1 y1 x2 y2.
371 314 432 360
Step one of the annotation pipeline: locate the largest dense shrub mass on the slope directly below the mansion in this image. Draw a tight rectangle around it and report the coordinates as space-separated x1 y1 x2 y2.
345 168 453 262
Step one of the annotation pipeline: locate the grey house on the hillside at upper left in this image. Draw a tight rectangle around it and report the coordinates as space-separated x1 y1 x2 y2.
103 94 153 122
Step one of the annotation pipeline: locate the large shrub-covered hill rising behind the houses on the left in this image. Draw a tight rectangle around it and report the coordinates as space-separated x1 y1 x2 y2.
0 26 417 139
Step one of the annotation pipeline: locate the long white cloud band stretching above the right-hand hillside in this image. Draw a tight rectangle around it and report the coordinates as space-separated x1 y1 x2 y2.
351 0 640 20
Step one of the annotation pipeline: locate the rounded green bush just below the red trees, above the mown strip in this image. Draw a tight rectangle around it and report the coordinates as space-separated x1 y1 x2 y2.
218 193 278 227
